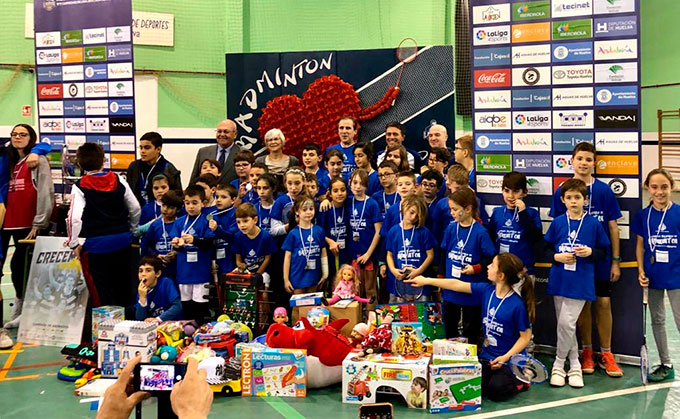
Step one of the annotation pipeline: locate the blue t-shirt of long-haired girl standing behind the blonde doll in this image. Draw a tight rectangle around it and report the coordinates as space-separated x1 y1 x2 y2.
347 196 383 260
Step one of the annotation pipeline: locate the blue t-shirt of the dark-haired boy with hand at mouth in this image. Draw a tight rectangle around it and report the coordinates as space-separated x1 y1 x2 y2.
488 205 543 273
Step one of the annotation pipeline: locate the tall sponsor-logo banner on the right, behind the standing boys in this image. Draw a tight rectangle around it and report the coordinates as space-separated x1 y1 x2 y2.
470 0 642 356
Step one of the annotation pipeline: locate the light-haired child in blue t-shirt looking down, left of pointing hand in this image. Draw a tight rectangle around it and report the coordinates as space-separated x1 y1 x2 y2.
385 195 435 304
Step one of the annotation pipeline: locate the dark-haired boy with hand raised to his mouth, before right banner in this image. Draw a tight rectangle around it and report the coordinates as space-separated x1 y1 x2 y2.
487 172 543 274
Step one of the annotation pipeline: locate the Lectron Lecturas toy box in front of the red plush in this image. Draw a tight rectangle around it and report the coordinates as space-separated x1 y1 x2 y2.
240 346 307 397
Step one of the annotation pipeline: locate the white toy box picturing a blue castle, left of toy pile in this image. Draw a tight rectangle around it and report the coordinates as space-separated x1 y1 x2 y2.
97 320 156 377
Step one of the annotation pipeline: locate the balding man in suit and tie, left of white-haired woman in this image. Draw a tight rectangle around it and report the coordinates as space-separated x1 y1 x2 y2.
191 119 241 182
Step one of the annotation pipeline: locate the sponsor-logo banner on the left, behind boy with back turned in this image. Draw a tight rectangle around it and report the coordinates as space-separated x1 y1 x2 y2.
33 0 136 176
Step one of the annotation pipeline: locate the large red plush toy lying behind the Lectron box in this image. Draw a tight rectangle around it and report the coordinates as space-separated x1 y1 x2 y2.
266 317 352 367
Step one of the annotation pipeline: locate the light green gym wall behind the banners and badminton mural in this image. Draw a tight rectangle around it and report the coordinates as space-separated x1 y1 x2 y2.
0 0 680 135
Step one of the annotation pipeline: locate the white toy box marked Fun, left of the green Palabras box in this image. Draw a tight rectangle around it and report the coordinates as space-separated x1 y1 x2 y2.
342 352 430 409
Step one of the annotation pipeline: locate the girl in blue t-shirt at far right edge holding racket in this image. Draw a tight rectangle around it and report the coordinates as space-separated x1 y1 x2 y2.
631 169 680 382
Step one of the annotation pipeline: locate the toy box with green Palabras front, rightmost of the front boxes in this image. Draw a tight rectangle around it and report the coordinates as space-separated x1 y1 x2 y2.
429 362 482 413
